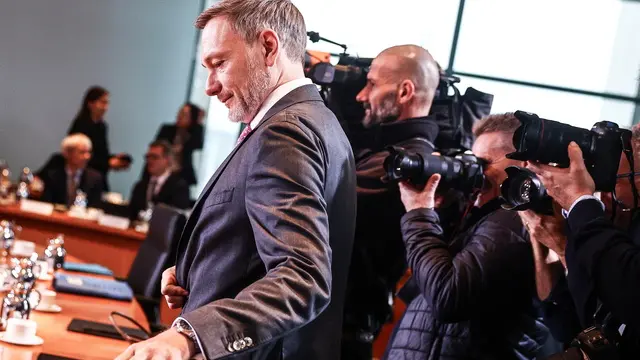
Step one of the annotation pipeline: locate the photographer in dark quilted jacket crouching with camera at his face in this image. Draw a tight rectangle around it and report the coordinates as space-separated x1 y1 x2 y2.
385 114 548 360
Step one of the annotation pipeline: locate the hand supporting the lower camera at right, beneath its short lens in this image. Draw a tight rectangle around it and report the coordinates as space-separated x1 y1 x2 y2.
518 210 567 265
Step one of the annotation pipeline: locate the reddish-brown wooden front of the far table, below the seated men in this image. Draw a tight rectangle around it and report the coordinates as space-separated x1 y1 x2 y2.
0 204 146 278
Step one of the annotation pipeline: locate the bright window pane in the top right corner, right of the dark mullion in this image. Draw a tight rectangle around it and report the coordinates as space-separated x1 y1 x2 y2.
454 0 640 97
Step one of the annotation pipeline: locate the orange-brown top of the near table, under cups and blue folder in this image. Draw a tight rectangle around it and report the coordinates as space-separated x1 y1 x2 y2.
0 248 149 360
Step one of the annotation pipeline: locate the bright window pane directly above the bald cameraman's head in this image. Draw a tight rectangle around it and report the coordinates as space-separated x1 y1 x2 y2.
293 0 458 67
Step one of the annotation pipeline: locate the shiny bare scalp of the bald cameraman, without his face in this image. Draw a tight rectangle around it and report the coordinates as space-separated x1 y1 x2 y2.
373 45 440 94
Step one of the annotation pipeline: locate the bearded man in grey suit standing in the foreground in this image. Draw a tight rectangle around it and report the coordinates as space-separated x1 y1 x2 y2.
118 0 356 360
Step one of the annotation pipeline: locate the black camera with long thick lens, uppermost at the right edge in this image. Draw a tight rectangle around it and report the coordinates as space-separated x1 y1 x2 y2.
507 111 631 192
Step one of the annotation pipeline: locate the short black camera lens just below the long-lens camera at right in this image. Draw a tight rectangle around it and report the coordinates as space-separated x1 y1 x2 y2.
500 166 553 215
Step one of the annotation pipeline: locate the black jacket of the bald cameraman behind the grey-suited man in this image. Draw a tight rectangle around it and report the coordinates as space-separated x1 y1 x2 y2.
345 118 438 332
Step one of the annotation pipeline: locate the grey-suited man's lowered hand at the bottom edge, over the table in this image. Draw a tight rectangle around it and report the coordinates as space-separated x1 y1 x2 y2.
116 329 196 360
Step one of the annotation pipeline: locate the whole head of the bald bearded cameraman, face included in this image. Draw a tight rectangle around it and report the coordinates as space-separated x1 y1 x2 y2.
356 45 440 127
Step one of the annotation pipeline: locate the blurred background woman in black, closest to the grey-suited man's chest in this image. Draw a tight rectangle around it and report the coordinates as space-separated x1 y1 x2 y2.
156 103 204 185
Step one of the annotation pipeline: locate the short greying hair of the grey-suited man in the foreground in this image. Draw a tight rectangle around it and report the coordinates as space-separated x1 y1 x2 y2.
196 0 307 64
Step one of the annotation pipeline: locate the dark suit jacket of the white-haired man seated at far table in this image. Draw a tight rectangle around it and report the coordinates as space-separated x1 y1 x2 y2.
38 155 104 207
